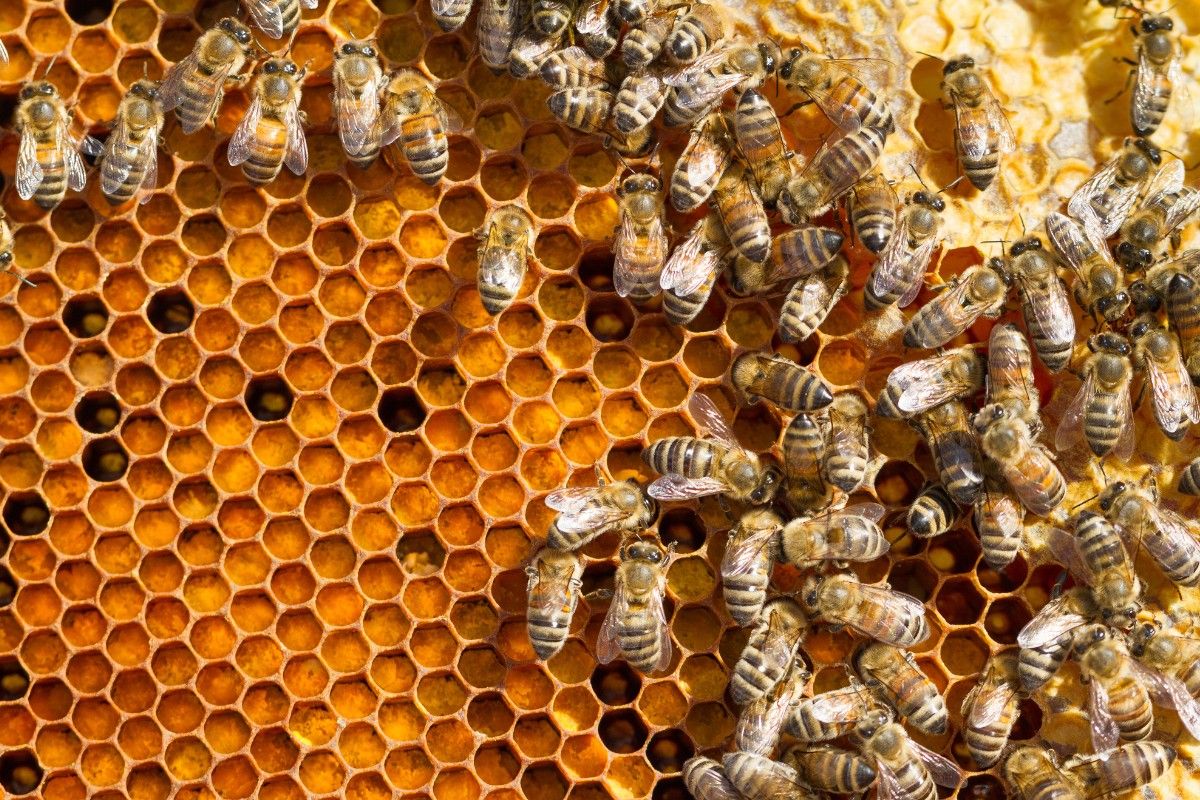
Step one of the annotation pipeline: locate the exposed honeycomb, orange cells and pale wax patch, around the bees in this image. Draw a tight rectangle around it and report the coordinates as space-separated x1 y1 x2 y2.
0 0 1200 800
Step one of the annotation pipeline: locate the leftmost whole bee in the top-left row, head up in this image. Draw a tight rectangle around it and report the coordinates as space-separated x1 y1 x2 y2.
13 80 101 209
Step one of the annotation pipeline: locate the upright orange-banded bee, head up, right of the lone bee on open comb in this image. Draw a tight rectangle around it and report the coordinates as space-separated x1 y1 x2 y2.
612 173 667 302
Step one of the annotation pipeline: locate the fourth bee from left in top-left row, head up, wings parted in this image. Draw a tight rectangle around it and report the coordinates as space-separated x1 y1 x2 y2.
229 59 308 185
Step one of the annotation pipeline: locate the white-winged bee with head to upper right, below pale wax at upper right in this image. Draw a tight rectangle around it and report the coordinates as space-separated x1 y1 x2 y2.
1067 138 1161 239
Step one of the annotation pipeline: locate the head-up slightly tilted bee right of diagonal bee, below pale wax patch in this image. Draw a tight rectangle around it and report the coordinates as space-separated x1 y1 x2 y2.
1008 236 1075 372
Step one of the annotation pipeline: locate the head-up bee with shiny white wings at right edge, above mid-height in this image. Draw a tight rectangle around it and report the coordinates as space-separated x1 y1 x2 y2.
1129 314 1200 441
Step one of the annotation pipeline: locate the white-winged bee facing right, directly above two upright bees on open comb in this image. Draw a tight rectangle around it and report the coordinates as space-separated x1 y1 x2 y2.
546 480 659 551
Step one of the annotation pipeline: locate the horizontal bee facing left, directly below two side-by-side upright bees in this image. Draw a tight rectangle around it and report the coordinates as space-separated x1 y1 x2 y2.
779 503 890 569
